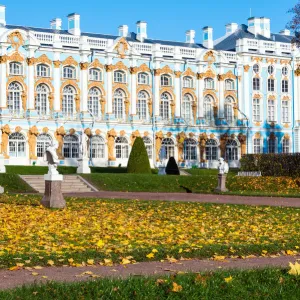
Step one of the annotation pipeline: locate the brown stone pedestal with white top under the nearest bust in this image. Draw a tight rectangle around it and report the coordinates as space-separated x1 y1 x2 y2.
41 174 66 208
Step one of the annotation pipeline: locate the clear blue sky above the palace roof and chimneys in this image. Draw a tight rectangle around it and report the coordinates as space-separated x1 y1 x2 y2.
0 0 297 42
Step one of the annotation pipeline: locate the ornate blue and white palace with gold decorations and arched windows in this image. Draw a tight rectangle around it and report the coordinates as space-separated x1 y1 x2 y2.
0 6 300 168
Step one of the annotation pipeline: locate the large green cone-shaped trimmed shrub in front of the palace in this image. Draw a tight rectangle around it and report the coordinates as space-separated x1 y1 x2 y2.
127 137 152 174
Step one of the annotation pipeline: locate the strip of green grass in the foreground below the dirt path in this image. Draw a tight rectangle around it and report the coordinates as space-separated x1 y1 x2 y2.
0 269 300 300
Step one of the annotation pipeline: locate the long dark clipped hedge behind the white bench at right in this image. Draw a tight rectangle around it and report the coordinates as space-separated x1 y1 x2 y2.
240 153 300 177
